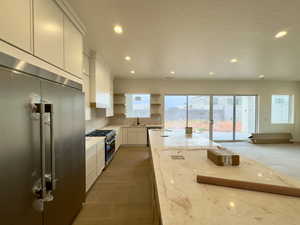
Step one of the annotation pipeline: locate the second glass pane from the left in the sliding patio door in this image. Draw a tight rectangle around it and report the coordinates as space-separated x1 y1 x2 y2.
188 96 210 138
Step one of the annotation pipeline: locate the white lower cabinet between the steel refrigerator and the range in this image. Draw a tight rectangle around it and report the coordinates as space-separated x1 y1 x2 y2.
85 139 105 192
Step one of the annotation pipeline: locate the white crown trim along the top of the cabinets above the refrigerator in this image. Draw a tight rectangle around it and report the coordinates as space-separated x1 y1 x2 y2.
55 0 87 36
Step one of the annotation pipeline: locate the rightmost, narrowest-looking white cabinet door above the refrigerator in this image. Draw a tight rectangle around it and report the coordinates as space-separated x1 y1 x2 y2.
64 16 83 77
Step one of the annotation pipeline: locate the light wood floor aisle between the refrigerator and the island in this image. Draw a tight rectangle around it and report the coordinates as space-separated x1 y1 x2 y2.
73 147 154 225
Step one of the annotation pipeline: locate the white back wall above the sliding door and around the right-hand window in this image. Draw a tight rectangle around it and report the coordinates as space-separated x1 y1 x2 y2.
114 79 300 140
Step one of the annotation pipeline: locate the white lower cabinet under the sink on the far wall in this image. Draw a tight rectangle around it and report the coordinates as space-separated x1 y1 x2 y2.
123 127 147 145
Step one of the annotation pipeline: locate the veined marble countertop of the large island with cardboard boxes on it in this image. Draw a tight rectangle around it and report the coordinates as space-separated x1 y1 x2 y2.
150 130 300 225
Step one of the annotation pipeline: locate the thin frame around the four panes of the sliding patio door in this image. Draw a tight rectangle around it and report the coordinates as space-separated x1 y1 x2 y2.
163 93 258 142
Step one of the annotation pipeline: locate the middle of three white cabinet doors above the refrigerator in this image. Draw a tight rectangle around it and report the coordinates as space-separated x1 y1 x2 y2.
34 0 63 68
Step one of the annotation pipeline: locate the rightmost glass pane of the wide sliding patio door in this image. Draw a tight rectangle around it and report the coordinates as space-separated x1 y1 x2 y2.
235 96 256 140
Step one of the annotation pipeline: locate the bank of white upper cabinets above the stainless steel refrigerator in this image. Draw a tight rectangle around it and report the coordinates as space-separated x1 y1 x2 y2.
0 0 89 82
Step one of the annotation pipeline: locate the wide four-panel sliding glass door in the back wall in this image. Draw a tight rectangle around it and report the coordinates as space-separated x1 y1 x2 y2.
164 95 257 141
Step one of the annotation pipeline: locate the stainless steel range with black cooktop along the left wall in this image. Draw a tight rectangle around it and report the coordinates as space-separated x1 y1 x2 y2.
86 130 116 165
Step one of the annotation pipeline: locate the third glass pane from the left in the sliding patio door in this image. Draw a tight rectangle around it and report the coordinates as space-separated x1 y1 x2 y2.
213 96 233 140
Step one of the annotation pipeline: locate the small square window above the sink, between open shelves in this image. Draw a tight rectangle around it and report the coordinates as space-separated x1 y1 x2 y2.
126 94 150 118
